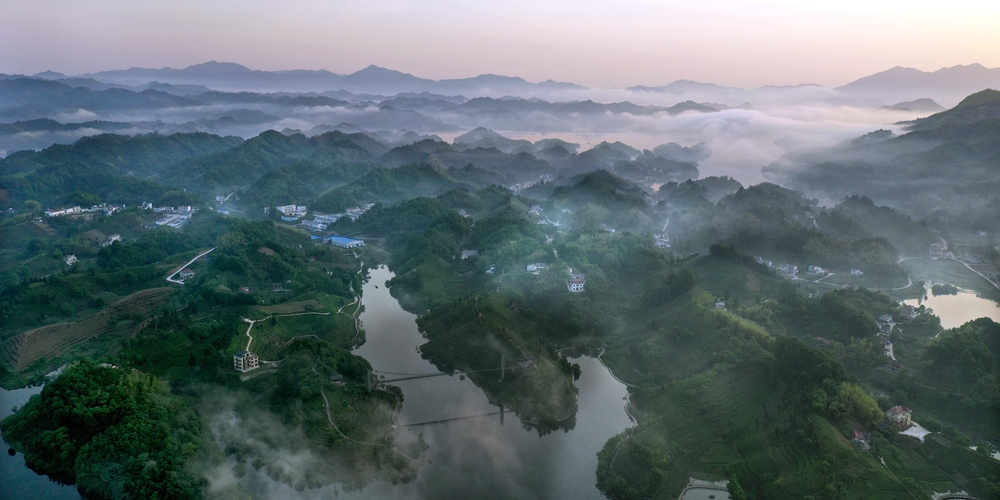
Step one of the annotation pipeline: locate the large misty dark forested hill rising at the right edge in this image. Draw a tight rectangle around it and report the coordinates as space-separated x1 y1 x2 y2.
763 90 1000 233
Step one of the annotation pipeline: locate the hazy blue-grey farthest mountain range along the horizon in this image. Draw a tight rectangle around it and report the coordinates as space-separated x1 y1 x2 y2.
7 61 1000 106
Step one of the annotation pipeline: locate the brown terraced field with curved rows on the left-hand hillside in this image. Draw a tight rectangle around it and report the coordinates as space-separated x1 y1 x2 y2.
3 287 174 371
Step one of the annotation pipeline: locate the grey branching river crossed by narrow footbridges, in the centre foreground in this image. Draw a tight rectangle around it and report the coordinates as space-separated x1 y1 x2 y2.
243 267 632 500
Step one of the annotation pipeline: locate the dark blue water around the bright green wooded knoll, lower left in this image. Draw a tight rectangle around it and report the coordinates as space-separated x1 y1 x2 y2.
0 374 80 500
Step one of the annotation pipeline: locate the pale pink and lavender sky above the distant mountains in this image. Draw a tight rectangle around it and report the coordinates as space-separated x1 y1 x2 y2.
0 0 1000 88
